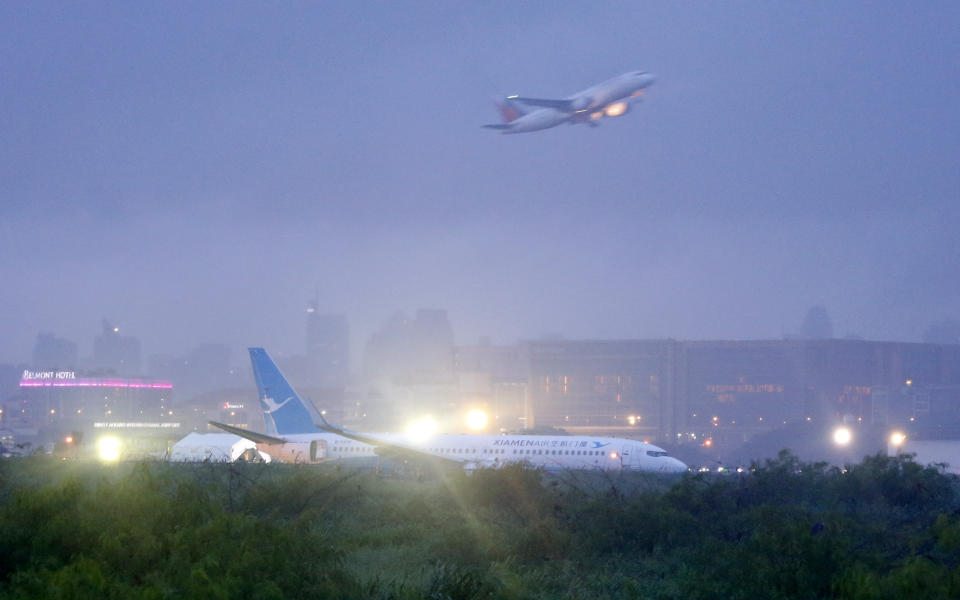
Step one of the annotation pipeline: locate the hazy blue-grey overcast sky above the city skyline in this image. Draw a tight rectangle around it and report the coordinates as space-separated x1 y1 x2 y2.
0 1 960 362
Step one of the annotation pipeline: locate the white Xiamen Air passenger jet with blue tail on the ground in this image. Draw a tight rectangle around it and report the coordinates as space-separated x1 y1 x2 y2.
210 348 687 473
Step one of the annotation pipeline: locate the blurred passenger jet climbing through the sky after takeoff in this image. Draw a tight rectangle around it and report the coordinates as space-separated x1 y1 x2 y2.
484 71 654 133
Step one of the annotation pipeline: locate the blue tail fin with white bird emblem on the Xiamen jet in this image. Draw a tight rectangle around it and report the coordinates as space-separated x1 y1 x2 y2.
250 348 317 436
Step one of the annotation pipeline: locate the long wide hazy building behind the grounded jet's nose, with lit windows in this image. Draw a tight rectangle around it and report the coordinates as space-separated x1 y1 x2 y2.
457 339 960 445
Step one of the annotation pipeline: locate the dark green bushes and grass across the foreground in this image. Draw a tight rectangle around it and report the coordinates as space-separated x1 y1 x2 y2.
0 452 960 600
